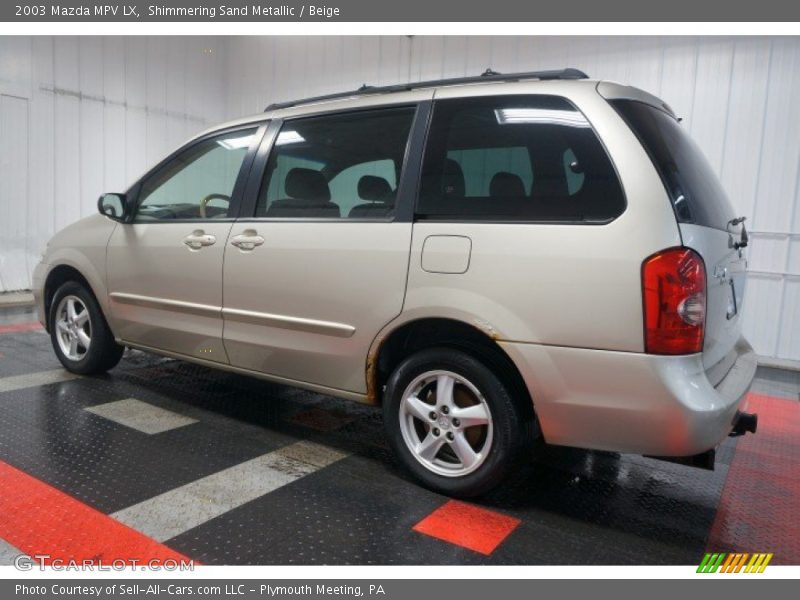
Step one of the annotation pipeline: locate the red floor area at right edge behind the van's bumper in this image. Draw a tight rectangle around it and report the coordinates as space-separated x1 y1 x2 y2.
707 394 800 565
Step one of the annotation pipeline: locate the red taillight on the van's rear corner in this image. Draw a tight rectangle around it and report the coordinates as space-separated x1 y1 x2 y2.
642 248 706 354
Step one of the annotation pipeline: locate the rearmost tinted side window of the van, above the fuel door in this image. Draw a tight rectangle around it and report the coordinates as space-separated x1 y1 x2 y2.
417 96 625 222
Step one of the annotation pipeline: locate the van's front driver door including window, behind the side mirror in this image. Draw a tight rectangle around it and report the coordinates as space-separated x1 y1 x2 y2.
107 127 257 363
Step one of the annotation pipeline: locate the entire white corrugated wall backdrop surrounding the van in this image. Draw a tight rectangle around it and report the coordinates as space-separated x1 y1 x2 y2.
0 36 800 361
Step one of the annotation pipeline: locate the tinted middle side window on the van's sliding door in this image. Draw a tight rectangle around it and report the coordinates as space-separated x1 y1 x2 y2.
256 107 415 219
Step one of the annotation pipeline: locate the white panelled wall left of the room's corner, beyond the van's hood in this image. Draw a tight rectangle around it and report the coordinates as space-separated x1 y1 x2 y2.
0 36 225 292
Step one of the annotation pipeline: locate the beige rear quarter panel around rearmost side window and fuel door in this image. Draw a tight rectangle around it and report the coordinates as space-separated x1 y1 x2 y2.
404 81 681 352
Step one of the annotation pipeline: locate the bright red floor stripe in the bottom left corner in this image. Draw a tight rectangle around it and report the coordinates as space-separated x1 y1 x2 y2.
0 461 194 565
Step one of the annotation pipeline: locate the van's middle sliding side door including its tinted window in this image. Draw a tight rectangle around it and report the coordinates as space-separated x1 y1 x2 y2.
217 106 416 394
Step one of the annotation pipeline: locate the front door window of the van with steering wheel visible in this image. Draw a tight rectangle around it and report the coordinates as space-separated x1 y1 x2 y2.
136 128 257 221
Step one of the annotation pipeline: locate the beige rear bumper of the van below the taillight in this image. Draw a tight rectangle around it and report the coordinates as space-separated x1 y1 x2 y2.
500 338 756 456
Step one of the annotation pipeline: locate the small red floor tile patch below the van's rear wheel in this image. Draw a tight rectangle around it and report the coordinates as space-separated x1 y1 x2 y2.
414 500 520 556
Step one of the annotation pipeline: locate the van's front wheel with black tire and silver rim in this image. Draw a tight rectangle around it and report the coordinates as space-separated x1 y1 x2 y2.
48 281 125 375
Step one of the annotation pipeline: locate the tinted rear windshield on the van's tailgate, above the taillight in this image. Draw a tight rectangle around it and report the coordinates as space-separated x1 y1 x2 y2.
611 100 736 229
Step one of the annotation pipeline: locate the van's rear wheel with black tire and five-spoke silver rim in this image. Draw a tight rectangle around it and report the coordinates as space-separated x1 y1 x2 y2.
383 348 532 497
